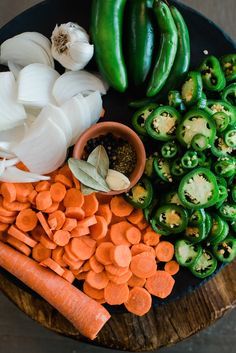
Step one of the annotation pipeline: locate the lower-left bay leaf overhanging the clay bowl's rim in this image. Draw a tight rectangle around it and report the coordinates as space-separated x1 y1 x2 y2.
68 158 110 192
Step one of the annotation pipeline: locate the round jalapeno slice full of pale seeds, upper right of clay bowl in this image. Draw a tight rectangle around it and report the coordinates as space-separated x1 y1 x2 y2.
145 106 180 141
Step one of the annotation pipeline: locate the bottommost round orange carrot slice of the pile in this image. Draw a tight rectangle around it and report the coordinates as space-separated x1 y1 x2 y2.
124 287 152 316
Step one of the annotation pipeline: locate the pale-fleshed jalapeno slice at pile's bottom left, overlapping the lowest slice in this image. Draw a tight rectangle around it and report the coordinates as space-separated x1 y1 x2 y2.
175 239 202 267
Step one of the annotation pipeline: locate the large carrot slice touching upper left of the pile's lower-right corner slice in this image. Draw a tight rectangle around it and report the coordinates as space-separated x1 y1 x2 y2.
130 253 157 278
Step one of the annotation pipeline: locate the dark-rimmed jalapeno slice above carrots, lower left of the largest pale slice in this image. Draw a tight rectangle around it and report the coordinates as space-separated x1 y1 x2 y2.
154 203 188 234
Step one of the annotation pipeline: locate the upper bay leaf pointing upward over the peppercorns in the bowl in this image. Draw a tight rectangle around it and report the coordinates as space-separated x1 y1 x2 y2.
87 145 109 178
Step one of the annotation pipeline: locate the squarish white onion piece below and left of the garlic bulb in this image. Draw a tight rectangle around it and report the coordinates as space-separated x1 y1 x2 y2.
18 63 60 108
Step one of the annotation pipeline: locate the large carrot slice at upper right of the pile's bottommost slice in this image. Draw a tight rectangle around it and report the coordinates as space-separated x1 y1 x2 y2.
145 271 175 299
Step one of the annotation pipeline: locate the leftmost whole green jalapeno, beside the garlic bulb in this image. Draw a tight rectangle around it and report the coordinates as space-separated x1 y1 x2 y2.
91 0 127 92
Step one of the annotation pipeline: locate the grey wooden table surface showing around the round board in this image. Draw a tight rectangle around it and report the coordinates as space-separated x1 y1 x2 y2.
0 0 236 353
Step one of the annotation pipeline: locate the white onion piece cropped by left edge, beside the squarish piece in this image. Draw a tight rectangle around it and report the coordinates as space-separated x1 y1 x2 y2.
0 72 26 131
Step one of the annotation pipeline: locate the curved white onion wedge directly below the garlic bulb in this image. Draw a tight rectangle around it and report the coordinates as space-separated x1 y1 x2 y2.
53 70 106 105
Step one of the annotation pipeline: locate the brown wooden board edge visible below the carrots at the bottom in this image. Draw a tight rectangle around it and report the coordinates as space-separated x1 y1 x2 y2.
0 262 236 352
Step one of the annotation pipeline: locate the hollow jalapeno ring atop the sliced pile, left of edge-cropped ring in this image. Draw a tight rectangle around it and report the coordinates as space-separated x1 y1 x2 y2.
199 55 226 92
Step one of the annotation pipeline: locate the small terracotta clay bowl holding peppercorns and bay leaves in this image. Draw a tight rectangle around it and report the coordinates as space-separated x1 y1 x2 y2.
73 121 146 195
